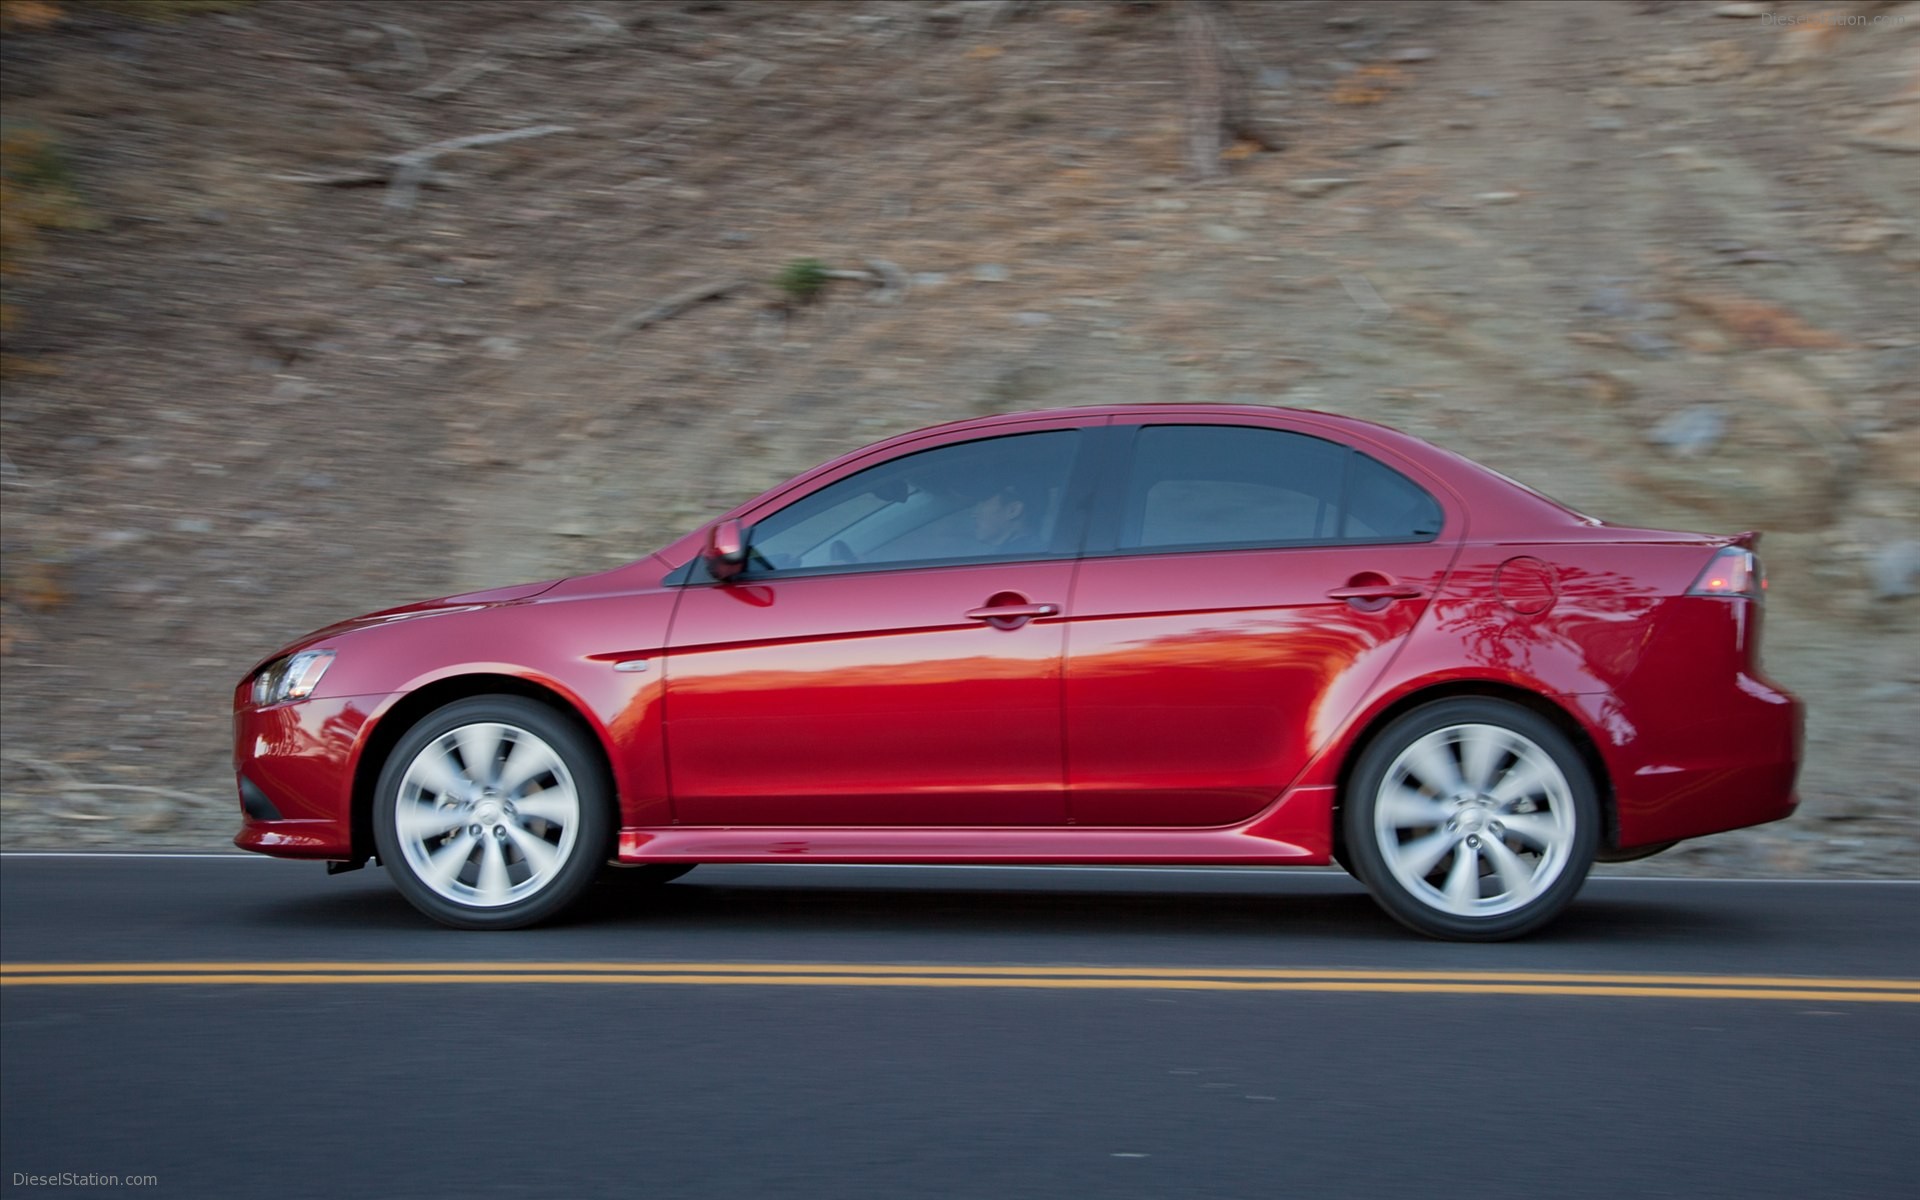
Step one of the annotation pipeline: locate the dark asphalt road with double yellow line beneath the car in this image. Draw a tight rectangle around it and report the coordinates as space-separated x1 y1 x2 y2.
0 856 1920 1200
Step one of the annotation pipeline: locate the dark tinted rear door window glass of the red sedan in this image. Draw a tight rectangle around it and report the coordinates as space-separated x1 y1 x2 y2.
1117 424 1440 549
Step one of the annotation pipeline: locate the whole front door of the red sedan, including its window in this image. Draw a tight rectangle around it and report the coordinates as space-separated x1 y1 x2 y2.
664 420 1089 826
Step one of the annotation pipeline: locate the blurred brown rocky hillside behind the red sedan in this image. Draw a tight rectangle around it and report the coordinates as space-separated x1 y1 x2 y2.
0 0 1920 874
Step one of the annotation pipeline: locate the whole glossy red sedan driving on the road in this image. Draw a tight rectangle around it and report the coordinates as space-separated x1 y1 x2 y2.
234 405 1803 939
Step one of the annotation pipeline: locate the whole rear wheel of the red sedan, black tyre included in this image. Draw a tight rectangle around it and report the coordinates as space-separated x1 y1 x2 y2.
1342 697 1599 941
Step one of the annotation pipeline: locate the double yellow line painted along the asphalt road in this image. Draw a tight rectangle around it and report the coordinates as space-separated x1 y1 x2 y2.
0 962 1920 1004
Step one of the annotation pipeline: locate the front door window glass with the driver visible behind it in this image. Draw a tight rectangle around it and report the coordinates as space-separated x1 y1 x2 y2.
751 430 1081 574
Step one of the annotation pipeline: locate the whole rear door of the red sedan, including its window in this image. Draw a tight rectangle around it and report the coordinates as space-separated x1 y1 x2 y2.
1066 419 1457 826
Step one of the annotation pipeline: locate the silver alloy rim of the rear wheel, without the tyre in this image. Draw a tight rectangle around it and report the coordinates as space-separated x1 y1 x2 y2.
1373 724 1578 918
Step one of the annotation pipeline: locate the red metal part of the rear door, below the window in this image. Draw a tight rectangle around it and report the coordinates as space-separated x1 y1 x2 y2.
1066 543 1455 826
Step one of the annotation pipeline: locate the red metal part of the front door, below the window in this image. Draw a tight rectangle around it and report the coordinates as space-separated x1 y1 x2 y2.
666 563 1073 826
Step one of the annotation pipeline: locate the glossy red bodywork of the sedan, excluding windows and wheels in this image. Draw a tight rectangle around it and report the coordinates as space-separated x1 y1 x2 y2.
234 405 1803 864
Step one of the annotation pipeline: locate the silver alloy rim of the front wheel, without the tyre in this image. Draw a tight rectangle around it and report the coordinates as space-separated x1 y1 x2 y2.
394 722 580 908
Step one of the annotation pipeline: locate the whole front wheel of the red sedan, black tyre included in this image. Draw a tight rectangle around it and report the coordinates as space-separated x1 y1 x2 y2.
372 695 614 929
